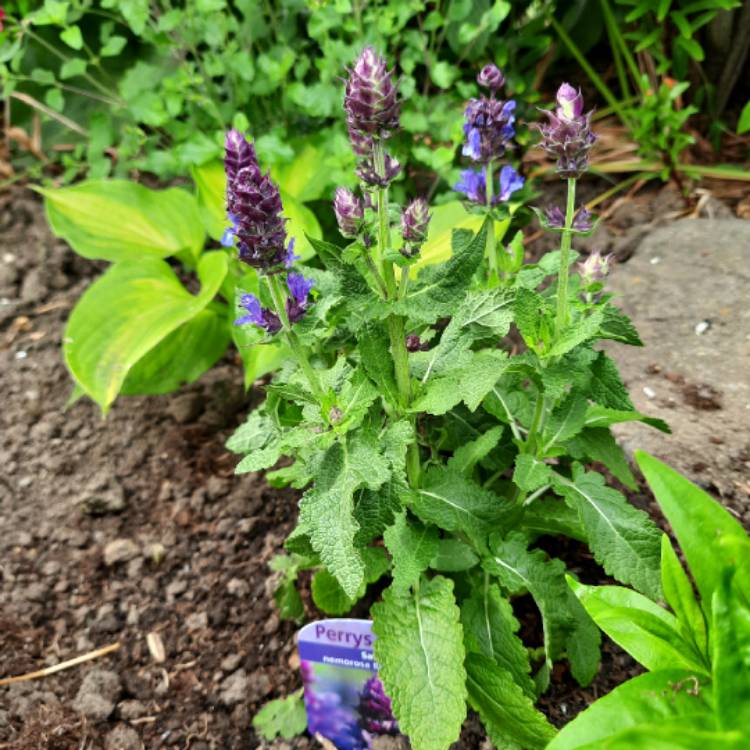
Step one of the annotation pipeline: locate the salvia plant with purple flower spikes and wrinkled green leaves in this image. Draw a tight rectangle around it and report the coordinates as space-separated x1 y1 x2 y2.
226 48 667 750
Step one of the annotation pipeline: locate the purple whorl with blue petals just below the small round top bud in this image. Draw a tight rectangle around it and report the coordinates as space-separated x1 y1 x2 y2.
462 95 516 164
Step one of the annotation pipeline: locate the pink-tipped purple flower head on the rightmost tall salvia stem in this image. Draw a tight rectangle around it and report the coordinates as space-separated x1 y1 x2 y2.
537 83 596 178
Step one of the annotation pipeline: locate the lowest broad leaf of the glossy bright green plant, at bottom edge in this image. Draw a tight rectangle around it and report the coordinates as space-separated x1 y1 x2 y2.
547 669 713 750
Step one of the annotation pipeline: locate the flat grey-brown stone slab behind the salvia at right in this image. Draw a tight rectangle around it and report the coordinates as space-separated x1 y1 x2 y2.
608 214 750 525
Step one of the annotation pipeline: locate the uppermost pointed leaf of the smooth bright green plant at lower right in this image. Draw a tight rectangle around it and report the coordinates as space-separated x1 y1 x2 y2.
635 451 750 607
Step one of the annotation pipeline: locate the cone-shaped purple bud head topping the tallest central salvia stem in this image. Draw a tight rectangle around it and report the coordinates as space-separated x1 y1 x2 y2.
344 47 400 141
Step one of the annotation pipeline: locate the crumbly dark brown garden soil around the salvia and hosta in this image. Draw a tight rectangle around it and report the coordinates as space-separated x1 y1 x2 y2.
0 182 728 750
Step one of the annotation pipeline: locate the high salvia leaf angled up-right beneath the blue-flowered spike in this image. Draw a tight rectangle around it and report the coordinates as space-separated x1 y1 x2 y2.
394 222 494 323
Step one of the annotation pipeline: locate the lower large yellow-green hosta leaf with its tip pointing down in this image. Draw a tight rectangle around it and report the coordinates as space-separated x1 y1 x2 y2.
63 252 227 412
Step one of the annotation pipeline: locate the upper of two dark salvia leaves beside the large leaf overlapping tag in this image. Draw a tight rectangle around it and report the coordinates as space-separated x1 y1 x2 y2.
461 581 536 699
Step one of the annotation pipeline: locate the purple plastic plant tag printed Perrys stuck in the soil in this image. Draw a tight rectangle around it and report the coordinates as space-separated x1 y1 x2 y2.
297 619 406 750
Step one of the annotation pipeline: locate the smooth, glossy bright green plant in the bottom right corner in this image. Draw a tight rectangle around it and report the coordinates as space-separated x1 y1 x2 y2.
549 454 750 750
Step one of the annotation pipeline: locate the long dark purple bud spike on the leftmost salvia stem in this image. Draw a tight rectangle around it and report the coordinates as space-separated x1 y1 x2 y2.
222 130 287 272
